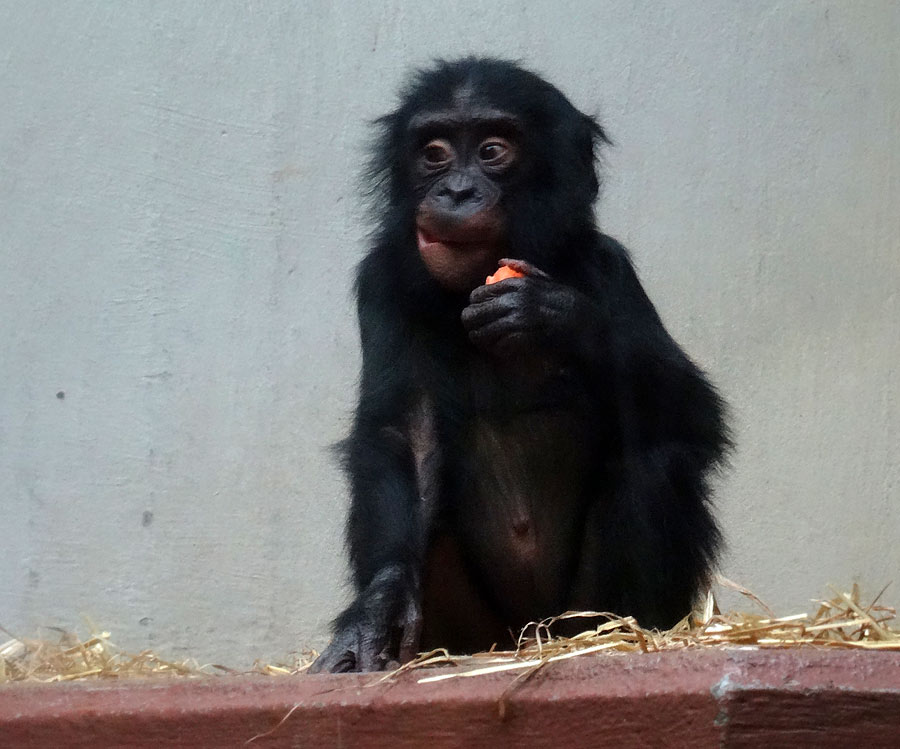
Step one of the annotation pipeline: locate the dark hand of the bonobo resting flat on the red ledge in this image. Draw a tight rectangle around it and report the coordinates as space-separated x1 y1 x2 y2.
309 567 422 674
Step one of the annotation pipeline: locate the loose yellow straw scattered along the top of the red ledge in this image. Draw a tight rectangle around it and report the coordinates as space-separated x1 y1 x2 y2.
0 578 900 684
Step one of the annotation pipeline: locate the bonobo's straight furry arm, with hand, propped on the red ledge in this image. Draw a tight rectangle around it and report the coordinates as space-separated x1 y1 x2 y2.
311 259 426 673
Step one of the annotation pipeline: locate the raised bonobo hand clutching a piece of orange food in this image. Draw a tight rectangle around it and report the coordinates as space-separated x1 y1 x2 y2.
462 258 598 356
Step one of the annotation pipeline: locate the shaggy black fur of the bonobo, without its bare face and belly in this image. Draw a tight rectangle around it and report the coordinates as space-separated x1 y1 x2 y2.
315 58 729 670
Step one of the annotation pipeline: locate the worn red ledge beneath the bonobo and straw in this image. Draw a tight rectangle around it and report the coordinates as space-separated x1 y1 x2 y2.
0 649 900 749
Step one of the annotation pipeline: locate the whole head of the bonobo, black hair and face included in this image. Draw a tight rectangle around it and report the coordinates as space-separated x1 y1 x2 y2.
372 58 605 292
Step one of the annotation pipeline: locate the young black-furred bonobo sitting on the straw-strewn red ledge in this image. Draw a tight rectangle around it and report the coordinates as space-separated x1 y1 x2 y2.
313 58 728 672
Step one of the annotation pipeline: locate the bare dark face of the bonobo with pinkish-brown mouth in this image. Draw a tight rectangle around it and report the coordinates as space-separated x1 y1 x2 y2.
409 99 521 292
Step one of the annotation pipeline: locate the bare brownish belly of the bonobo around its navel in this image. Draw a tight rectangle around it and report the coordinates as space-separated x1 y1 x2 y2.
451 409 591 628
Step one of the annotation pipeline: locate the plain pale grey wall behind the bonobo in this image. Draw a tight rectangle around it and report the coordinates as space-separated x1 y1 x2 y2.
0 0 900 664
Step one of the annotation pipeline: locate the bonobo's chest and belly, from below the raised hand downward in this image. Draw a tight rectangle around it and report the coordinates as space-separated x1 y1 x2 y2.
447 358 591 624
